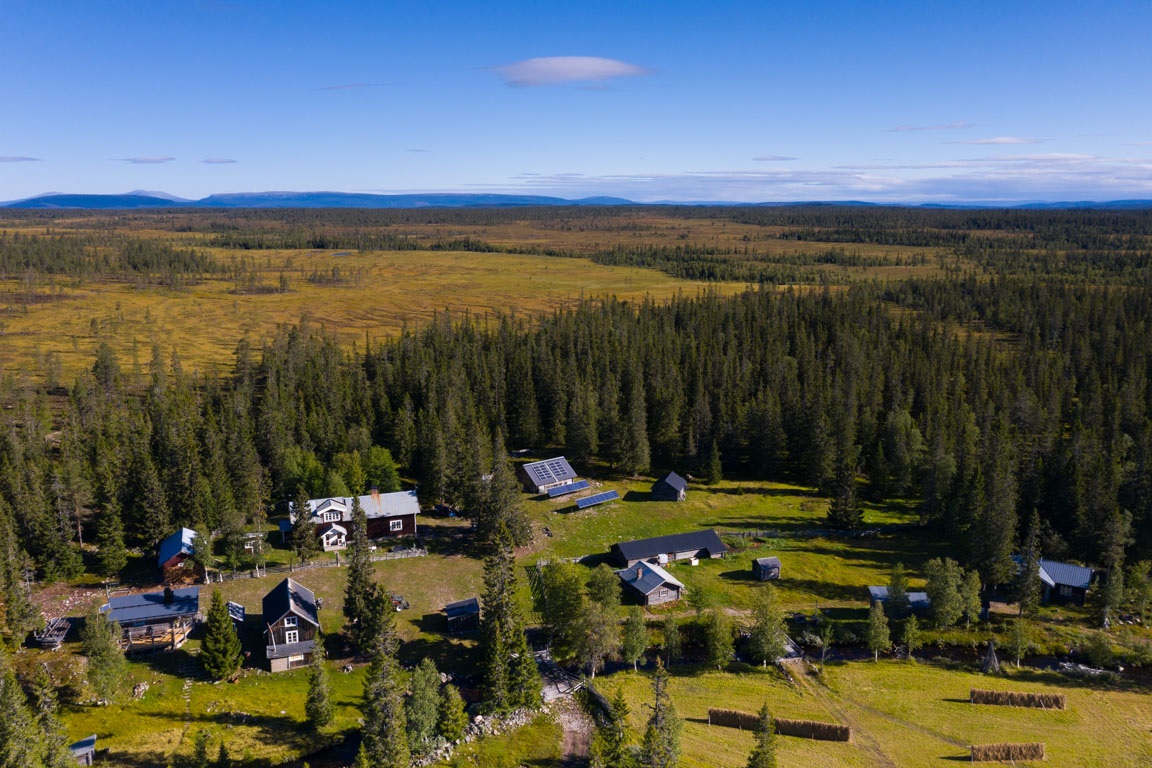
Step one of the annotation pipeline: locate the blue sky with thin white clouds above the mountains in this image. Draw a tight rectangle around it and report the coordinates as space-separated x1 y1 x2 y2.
0 0 1152 203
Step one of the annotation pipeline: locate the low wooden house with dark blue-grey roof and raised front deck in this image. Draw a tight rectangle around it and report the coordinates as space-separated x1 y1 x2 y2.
100 587 200 653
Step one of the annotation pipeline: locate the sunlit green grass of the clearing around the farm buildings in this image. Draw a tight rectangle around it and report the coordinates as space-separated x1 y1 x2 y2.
33 480 1152 768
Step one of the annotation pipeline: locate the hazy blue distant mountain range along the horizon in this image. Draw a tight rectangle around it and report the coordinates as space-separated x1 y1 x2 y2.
0 190 1152 210
